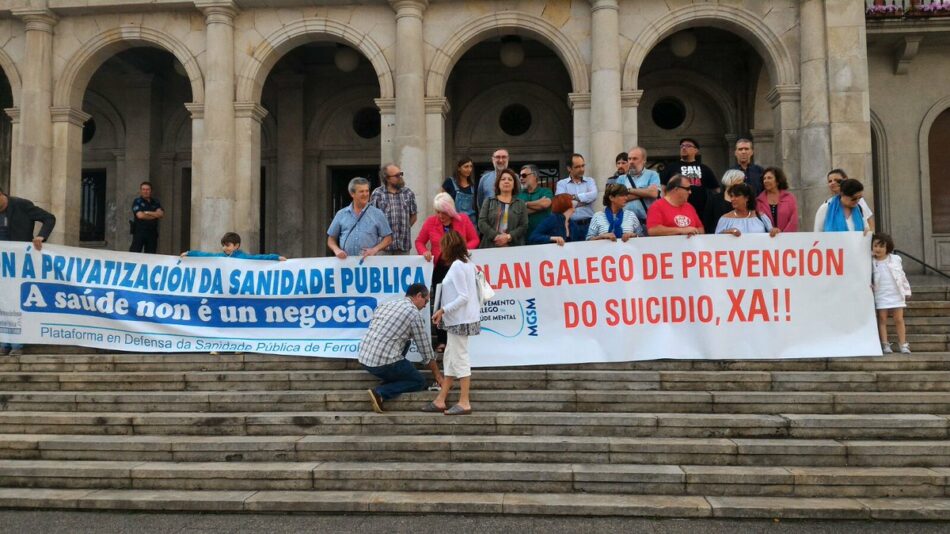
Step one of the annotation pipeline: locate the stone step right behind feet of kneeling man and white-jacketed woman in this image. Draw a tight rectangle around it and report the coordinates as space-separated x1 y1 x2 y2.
0 389 950 414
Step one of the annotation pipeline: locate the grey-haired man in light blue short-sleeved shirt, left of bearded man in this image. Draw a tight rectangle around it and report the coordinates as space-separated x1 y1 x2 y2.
327 177 393 260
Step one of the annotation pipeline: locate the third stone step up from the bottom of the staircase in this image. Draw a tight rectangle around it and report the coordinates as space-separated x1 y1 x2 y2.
0 434 950 467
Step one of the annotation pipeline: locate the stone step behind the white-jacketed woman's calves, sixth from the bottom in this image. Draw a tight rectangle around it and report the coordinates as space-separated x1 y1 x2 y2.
0 369 950 392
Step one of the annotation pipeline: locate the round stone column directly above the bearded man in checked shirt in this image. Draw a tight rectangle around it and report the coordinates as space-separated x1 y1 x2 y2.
390 0 429 203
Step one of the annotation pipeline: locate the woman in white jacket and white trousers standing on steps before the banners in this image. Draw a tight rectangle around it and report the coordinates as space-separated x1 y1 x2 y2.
422 232 481 415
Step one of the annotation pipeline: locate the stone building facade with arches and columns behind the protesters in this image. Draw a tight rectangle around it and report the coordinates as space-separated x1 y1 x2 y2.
0 0 950 267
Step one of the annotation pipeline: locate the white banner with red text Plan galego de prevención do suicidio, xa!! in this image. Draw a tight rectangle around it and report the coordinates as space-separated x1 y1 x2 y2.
469 232 881 367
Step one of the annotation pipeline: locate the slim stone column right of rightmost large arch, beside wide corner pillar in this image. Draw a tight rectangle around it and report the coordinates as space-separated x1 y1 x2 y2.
800 0 832 220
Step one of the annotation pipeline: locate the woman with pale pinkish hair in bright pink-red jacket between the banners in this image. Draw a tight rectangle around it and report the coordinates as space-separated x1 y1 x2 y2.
416 193 479 352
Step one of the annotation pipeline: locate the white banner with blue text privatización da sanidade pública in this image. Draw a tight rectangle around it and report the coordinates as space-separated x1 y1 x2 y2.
0 245 432 358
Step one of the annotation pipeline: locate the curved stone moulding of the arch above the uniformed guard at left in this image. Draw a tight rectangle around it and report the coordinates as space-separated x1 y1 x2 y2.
53 25 204 109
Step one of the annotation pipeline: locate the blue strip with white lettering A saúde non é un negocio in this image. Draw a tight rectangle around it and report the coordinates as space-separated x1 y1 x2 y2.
20 282 377 328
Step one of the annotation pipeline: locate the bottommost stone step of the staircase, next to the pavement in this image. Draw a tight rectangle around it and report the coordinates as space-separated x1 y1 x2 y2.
0 488 950 520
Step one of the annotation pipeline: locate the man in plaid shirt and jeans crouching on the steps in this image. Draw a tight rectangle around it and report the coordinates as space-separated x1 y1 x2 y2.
359 284 442 413
